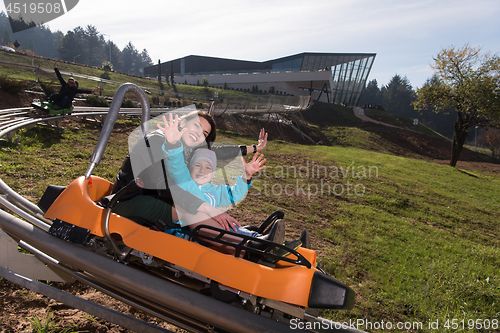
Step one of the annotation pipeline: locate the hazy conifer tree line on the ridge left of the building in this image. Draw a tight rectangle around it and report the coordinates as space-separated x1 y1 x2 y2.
0 11 153 75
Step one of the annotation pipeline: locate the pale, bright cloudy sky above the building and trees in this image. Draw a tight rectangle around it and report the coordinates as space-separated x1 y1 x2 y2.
0 0 500 88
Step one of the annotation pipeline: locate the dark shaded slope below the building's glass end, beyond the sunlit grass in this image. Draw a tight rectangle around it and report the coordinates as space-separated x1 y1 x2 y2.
303 102 493 162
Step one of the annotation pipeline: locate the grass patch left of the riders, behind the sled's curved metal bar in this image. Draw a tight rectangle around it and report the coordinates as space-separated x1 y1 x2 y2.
0 124 128 203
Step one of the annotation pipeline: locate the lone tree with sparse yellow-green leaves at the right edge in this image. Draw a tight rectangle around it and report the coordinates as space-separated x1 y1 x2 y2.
414 44 500 167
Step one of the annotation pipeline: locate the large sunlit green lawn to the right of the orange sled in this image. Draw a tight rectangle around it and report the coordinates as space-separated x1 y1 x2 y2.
226 132 500 332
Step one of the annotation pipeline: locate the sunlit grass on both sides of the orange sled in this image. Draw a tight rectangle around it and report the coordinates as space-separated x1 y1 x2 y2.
0 118 500 332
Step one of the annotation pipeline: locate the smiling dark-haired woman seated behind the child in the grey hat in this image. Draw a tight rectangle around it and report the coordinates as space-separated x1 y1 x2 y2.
112 111 272 240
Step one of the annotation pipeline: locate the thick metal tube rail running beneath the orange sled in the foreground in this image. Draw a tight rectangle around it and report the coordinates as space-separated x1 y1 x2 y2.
0 211 302 333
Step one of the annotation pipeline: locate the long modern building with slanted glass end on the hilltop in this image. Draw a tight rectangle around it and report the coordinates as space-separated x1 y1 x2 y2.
144 53 376 106
